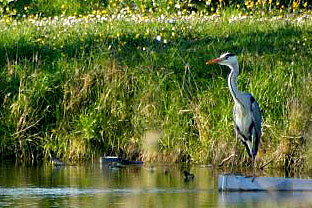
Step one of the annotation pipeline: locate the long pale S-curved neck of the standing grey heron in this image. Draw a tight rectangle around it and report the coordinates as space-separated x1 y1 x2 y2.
228 63 244 106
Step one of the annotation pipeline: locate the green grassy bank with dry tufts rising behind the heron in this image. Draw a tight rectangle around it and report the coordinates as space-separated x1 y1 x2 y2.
0 9 312 171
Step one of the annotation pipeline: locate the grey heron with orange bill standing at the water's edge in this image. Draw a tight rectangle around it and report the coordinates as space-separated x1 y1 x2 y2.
206 53 261 166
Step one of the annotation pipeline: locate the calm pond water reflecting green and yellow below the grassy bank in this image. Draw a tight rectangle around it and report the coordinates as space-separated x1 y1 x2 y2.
0 163 312 208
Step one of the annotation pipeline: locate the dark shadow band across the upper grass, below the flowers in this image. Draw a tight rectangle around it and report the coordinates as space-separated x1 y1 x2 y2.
0 22 312 78
